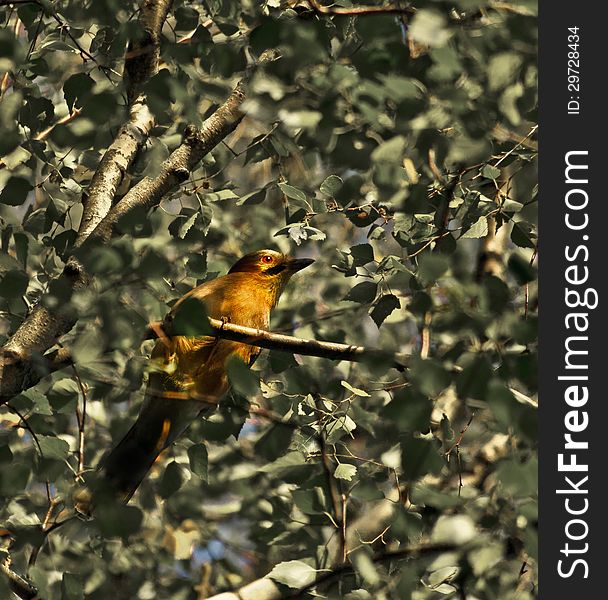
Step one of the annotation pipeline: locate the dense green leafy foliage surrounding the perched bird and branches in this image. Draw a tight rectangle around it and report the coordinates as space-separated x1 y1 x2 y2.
0 0 537 600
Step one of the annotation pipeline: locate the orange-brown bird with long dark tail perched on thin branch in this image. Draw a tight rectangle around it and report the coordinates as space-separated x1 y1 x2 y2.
96 250 313 505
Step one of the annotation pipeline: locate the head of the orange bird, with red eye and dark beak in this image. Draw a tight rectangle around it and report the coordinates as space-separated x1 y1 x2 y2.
228 250 314 305
